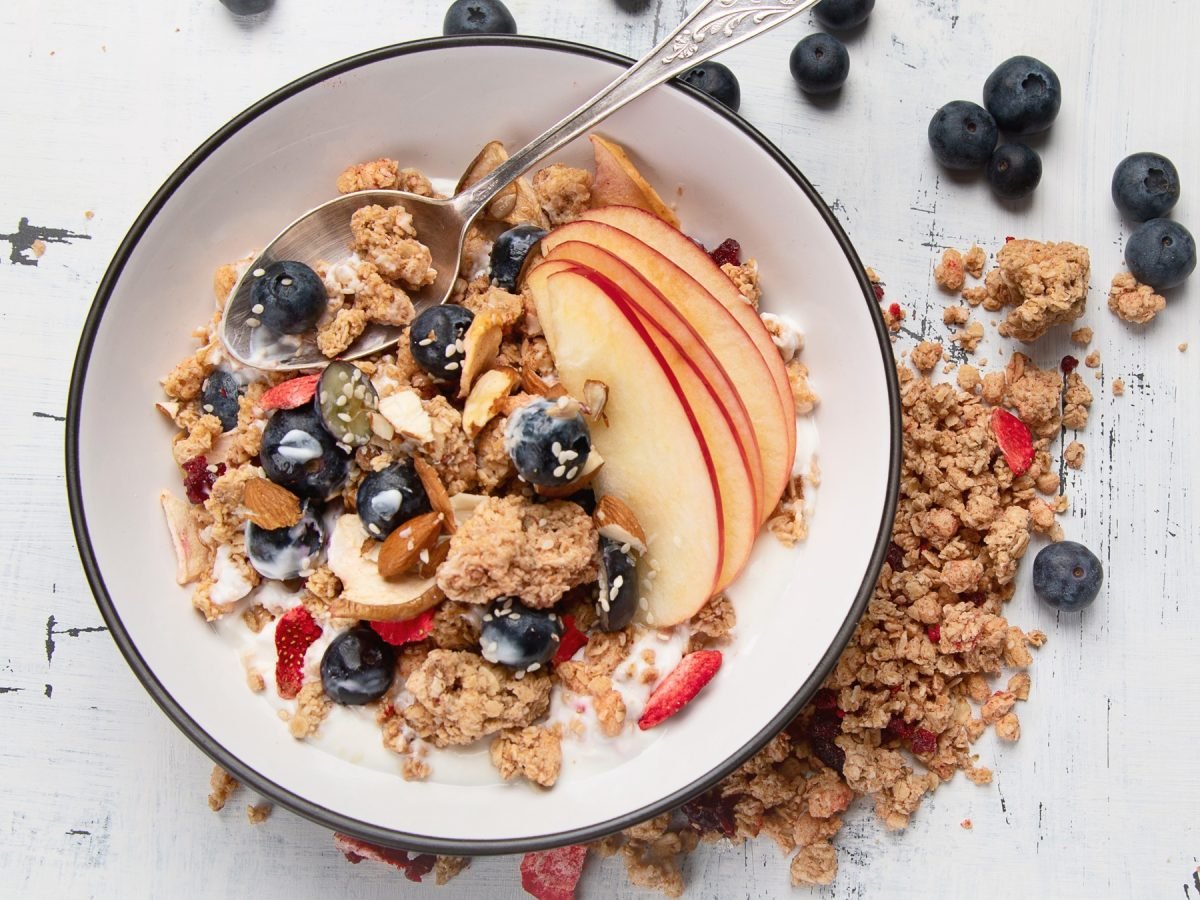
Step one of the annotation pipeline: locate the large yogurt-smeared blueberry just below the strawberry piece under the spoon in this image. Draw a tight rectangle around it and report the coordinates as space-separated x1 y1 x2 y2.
259 404 349 500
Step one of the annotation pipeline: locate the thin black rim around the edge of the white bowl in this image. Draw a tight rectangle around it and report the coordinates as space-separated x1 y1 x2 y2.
65 35 901 856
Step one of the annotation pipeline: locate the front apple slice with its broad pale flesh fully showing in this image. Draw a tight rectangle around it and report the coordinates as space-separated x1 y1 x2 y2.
530 264 722 625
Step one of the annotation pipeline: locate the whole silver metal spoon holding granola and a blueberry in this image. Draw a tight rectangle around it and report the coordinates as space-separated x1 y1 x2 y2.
221 0 818 370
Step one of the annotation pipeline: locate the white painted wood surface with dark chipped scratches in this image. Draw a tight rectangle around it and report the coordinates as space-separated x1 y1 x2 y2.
0 0 1200 900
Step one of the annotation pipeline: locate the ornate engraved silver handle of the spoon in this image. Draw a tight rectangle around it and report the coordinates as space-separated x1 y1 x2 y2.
452 0 818 218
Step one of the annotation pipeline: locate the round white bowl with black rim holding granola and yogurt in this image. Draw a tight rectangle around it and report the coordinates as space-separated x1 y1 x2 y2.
67 38 900 854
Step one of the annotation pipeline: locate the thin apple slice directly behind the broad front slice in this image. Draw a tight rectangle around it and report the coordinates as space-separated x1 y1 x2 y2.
529 256 761 592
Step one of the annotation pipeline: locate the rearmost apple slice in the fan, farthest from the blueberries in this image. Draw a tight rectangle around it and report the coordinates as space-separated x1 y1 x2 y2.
578 206 796 482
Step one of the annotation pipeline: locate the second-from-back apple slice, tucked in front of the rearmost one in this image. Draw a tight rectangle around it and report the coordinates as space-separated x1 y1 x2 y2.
542 217 796 513
